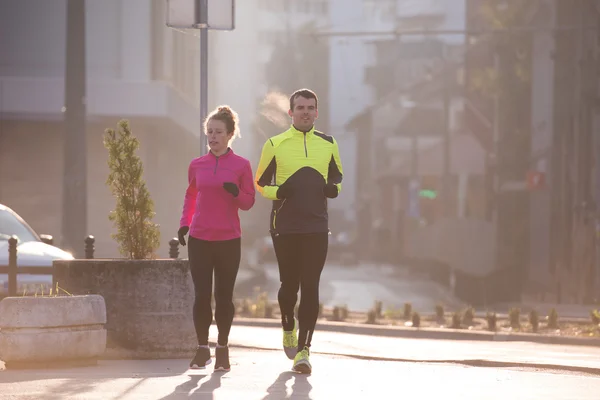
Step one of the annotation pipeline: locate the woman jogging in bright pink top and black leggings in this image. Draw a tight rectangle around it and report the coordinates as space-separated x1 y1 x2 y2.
178 106 255 371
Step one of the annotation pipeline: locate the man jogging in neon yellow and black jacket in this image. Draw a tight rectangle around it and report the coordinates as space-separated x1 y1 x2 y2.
255 89 342 373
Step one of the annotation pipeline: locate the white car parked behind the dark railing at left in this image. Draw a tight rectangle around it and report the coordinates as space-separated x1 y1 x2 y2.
0 204 73 296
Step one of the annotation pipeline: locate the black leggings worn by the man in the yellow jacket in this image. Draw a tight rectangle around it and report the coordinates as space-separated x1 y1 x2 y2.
272 232 329 349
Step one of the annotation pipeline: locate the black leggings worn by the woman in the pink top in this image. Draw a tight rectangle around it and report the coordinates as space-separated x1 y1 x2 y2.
188 236 242 346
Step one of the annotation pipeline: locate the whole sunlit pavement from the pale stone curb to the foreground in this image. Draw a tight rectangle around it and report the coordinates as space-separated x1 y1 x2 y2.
0 326 600 400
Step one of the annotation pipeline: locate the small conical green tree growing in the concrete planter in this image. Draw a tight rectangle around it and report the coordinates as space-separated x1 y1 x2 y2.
104 120 160 260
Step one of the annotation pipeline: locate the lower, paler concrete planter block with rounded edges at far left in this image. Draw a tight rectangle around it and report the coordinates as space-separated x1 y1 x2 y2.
0 296 106 368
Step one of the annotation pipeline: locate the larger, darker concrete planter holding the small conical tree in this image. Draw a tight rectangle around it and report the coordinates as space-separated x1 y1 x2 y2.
54 259 197 358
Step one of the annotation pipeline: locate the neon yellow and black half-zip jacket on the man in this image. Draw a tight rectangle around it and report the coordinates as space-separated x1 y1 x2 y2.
255 125 343 234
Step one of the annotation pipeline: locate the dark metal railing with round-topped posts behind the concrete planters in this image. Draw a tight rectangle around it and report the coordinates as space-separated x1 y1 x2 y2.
0 235 179 296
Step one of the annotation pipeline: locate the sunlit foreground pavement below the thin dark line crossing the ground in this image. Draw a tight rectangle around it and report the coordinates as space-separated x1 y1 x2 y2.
0 349 600 400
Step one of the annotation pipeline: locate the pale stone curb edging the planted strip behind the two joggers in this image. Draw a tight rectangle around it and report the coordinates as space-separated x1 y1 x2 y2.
233 318 600 347
